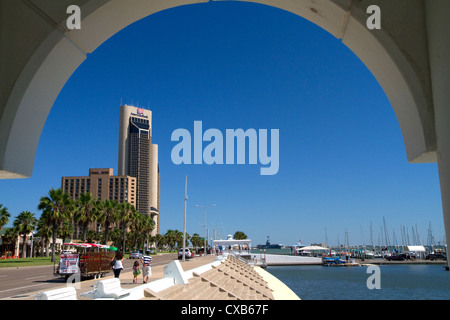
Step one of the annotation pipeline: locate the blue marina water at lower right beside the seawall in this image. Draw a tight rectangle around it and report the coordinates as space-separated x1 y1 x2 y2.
265 265 450 300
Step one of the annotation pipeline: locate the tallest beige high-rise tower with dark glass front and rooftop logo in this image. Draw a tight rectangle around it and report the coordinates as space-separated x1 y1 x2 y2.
118 105 160 235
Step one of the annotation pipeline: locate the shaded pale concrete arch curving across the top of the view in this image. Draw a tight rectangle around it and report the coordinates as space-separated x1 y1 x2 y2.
0 0 436 178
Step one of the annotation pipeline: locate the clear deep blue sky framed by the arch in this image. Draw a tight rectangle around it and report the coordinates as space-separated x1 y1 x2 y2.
0 2 444 245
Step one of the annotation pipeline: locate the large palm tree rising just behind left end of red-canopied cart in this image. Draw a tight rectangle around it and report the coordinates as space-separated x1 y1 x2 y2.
38 188 71 262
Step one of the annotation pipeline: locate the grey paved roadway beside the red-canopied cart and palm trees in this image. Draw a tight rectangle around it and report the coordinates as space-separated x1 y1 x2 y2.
0 254 177 300
